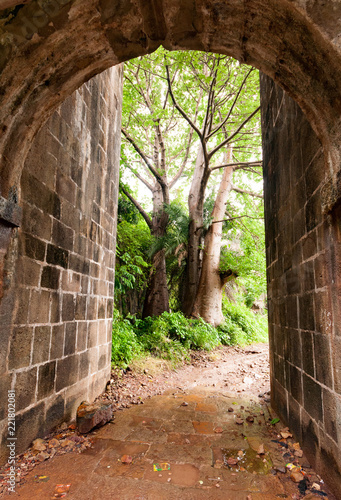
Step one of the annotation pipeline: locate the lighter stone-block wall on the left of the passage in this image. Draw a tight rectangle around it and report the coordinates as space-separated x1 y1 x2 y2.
0 66 122 459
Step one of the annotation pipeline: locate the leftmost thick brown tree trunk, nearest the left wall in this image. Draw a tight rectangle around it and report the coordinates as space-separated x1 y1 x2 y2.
142 183 169 318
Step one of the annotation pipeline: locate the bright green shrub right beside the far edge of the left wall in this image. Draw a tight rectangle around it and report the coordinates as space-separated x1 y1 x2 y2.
111 312 143 368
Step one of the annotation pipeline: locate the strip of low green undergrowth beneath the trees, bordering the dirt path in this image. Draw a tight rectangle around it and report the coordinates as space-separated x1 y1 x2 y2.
111 301 267 368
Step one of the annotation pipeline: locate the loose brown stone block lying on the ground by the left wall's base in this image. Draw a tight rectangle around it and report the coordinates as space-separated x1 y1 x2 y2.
77 401 112 434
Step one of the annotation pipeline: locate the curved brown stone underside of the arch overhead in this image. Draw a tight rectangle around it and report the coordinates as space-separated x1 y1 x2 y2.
0 0 341 198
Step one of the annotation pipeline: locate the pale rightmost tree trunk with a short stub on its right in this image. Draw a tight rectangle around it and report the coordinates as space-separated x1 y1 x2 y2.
192 150 236 326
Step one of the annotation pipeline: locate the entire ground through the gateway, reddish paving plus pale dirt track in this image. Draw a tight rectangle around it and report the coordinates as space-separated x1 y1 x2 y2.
0 344 335 500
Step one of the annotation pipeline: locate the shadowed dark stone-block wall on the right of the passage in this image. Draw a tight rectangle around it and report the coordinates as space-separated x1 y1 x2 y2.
261 75 341 494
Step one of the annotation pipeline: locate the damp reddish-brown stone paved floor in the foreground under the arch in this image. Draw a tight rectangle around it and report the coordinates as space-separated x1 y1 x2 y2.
5 387 316 500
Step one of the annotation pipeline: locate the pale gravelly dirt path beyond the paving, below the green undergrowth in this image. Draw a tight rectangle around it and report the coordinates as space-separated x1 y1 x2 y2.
101 344 270 410
